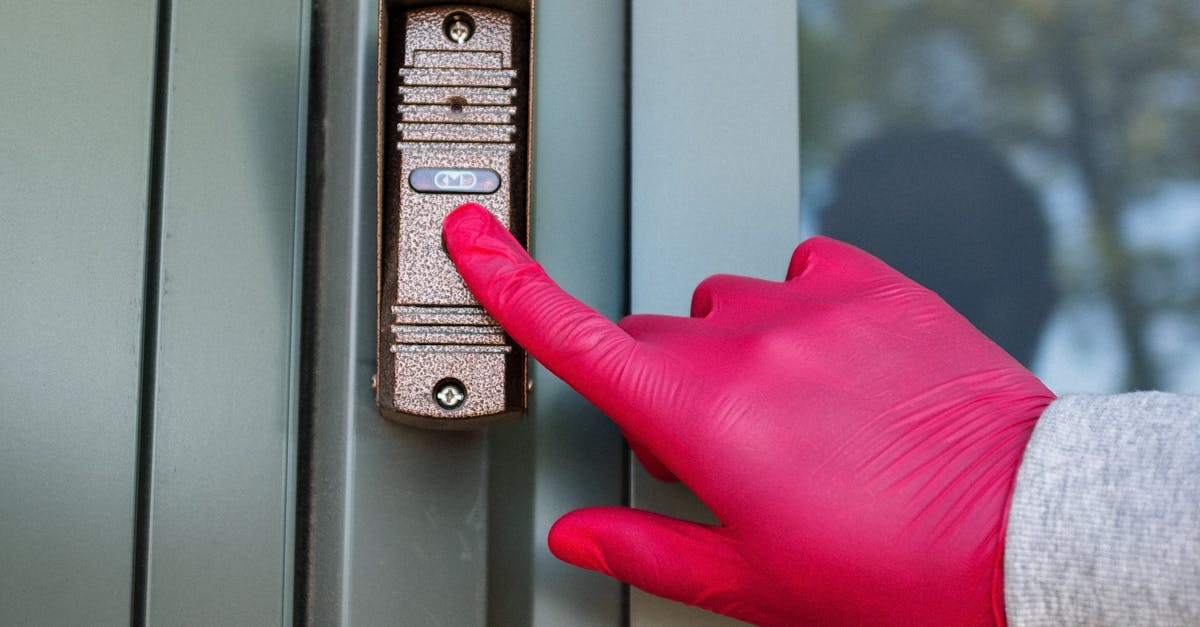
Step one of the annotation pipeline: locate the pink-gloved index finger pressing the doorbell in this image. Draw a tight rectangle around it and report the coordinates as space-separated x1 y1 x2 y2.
443 203 636 418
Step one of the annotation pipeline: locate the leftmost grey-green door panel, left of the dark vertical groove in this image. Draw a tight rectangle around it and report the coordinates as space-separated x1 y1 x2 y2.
0 1 156 625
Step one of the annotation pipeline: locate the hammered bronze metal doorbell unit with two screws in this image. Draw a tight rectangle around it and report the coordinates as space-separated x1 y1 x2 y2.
376 0 533 429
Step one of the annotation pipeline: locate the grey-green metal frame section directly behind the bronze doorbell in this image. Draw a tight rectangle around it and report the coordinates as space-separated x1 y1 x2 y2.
301 0 625 626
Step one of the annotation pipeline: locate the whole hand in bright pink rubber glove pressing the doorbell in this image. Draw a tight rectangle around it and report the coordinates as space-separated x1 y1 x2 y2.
444 205 1054 625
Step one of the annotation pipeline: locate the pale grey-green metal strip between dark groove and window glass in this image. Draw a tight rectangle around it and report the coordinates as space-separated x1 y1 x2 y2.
630 0 799 626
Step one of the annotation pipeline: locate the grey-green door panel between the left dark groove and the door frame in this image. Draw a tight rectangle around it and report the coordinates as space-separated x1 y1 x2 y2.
145 0 310 625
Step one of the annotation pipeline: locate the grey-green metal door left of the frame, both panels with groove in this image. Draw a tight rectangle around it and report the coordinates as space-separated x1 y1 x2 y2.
0 0 310 625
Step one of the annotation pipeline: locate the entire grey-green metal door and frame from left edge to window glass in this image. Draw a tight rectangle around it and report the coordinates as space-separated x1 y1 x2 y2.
9 0 798 626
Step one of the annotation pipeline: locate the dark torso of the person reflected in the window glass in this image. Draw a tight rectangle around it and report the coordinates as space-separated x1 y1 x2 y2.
821 130 1057 365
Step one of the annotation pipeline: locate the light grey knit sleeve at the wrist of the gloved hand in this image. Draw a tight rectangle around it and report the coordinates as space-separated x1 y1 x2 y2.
1004 393 1200 626
